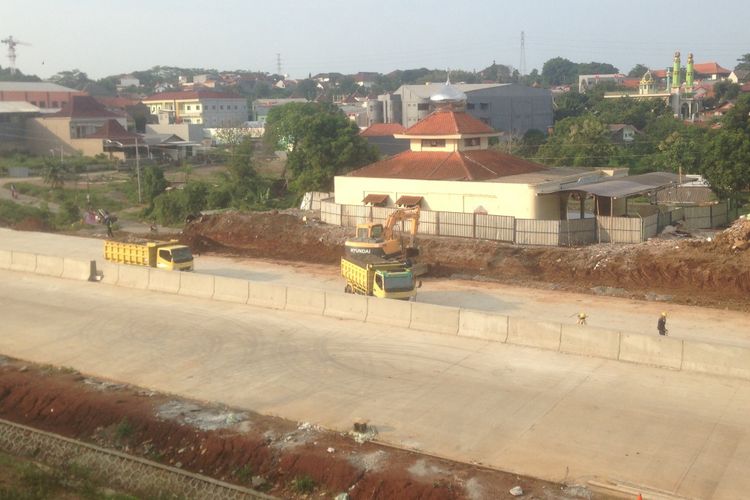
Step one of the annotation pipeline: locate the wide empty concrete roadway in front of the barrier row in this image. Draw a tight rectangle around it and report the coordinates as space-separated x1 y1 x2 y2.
0 271 750 499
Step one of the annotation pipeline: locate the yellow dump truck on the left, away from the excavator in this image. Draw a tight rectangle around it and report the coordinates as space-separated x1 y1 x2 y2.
104 240 193 271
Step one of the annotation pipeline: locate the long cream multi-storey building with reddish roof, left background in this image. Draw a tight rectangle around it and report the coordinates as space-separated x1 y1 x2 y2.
143 90 248 127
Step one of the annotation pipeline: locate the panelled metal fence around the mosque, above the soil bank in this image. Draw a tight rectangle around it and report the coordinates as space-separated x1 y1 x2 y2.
320 198 728 246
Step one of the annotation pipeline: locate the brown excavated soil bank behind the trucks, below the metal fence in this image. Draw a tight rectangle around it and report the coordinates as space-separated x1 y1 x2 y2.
181 211 750 311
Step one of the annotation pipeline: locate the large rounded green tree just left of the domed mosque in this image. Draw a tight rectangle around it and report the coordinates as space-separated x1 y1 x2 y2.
264 103 377 194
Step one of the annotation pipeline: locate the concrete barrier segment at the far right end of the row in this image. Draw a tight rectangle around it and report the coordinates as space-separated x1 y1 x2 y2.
682 340 750 379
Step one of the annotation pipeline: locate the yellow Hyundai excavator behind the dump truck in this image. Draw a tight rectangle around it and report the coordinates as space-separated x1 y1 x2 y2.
344 207 419 260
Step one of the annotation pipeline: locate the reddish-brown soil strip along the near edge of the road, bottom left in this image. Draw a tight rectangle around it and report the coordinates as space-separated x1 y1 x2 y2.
0 358 592 500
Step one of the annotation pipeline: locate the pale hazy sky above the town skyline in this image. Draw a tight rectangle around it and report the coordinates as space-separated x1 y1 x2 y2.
0 0 750 79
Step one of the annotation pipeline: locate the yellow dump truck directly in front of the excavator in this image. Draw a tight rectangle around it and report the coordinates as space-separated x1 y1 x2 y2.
341 257 421 300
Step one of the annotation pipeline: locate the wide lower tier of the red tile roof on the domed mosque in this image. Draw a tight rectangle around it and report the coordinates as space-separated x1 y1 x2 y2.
348 150 547 181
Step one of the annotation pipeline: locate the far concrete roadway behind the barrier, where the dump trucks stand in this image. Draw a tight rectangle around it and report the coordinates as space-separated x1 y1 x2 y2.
0 229 750 347
